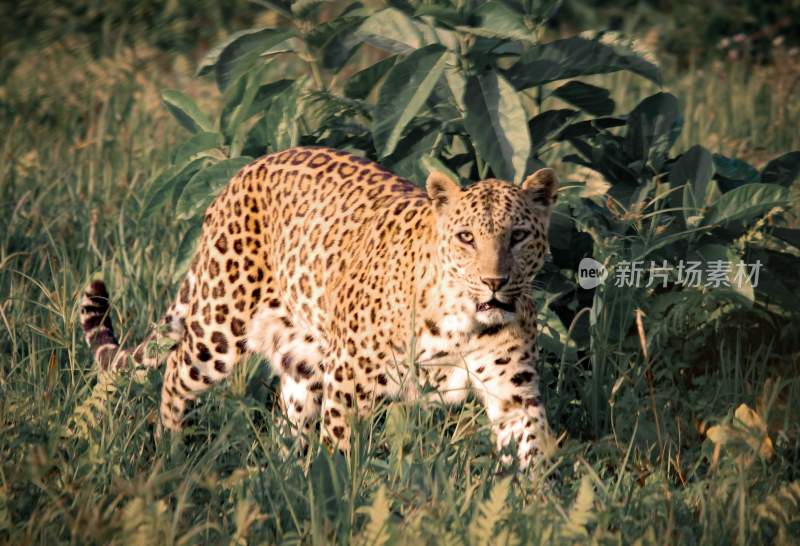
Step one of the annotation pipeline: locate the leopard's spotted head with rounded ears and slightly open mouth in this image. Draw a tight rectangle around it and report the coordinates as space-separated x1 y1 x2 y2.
427 169 559 325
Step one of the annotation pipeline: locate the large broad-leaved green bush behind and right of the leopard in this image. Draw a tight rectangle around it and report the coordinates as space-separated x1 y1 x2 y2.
152 0 800 439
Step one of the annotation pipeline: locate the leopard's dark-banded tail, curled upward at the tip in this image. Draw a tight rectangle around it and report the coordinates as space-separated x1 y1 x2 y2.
81 279 184 371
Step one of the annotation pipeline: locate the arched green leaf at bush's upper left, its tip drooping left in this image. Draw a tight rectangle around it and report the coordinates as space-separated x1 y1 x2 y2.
214 28 295 91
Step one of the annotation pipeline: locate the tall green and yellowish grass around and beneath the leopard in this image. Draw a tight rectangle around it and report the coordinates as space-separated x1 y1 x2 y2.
0 33 800 544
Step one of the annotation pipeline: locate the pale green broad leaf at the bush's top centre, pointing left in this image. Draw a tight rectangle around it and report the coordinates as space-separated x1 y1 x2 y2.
358 8 457 53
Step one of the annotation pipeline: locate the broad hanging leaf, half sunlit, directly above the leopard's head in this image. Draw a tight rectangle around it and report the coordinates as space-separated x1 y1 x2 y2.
464 72 531 183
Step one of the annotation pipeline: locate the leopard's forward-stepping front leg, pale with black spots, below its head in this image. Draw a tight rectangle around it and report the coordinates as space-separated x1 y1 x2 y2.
467 338 551 469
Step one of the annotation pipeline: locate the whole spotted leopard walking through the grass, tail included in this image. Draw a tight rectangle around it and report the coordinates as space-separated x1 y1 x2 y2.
80 147 559 470
